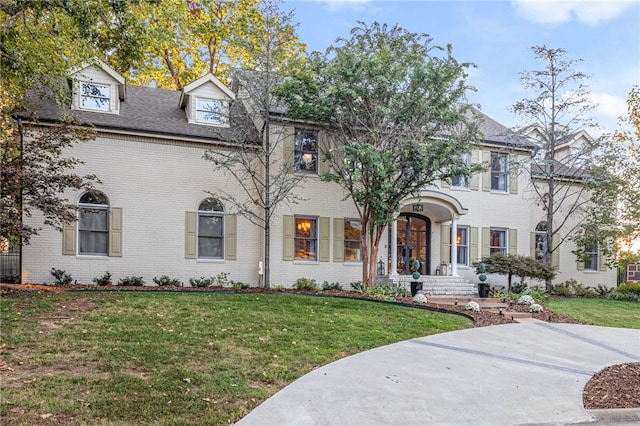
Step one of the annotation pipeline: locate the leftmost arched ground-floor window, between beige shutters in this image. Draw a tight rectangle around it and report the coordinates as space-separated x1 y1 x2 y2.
78 191 109 256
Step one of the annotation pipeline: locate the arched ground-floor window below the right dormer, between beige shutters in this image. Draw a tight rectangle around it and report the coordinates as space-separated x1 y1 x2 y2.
198 198 224 259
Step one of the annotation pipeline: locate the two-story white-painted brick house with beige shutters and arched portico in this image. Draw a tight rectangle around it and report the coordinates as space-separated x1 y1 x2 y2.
17 62 615 293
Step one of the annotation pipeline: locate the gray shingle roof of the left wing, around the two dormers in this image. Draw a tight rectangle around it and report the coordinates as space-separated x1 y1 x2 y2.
29 85 259 143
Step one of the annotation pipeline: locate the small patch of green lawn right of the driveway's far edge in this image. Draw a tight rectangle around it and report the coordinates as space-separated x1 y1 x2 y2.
545 297 640 328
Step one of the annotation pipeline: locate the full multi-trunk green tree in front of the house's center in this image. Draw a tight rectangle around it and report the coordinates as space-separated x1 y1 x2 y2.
279 23 480 287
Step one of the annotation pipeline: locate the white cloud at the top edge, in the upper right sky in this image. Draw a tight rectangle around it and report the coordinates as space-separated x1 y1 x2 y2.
511 0 634 26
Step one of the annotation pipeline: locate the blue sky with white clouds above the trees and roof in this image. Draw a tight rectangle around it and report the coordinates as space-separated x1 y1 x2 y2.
282 0 640 135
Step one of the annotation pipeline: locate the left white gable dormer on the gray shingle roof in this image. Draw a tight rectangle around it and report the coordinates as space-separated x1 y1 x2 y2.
69 59 126 114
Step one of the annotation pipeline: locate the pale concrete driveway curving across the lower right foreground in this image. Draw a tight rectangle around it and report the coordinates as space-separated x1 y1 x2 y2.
237 322 640 426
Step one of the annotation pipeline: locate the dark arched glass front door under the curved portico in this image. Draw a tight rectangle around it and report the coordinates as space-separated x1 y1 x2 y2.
396 213 431 275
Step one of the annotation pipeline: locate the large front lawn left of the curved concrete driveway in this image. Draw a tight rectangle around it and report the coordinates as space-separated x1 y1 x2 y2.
0 292 471 425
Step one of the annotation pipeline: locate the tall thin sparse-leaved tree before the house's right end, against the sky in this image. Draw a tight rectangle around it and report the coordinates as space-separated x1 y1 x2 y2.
511 46 616 290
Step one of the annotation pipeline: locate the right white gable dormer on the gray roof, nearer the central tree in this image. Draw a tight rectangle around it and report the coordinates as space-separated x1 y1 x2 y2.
180 73 235 127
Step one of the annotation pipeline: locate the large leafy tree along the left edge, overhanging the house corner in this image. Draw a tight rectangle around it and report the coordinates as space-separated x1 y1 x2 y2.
0 0 148 244
